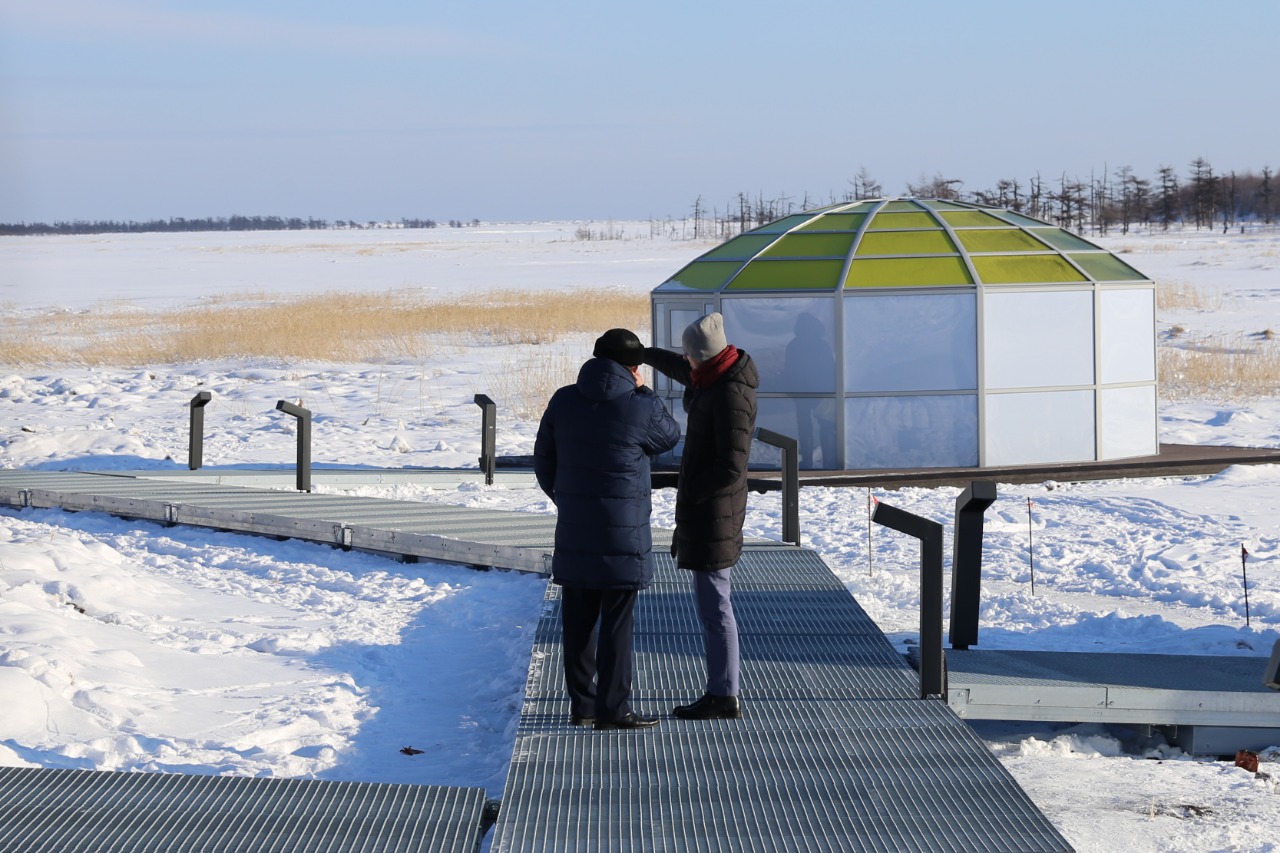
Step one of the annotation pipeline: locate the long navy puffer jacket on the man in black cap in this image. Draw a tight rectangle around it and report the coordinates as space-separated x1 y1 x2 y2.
534 359 680 589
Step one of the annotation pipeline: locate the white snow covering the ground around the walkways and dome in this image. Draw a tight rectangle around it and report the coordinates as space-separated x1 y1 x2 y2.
0 223 1280 852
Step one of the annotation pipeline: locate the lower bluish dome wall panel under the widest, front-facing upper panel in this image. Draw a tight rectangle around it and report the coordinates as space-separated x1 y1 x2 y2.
845 394 978 470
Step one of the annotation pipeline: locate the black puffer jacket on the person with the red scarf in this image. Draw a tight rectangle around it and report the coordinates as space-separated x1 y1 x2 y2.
644 347 760 571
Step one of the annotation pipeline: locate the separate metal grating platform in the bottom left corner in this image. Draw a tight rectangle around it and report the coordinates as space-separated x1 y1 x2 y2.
0 767 485 853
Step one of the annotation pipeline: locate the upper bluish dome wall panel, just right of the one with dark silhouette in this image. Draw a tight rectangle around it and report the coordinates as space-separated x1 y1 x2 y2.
845 292 978 392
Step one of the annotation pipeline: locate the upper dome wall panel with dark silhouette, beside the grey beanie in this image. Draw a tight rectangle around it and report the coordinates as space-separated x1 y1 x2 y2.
721 296 836 391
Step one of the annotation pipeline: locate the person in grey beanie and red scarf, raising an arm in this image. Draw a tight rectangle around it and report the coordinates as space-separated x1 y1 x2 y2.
644 314 760 720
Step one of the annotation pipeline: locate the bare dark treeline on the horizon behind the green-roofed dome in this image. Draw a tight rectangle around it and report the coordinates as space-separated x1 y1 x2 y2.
667 158 1277 240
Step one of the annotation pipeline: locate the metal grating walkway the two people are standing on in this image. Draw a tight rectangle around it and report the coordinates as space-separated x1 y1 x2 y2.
492 547 1071 853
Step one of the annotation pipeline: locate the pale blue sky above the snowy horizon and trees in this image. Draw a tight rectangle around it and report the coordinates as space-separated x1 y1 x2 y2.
0 0 1280 222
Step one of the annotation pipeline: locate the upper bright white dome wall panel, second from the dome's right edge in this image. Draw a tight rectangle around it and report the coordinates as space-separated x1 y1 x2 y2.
983 291 1093 388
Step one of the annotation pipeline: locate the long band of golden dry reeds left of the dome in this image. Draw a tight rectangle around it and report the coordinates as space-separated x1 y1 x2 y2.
0 291 649 366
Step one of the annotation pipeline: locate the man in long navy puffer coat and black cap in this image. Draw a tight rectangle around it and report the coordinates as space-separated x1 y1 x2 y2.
534 329 680 729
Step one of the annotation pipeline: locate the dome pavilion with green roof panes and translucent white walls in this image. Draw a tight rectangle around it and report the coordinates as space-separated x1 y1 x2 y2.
650 199 1158 470
